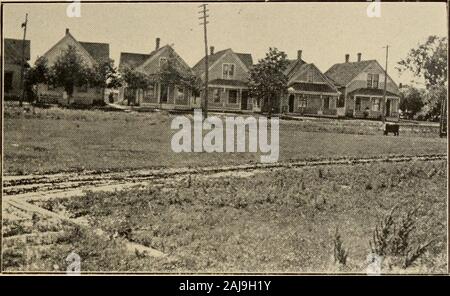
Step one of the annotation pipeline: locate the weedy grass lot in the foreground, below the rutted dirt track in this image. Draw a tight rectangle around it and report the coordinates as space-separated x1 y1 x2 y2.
3 161 447 273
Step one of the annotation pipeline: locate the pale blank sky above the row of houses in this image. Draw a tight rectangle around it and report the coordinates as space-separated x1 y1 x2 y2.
3 2 447 83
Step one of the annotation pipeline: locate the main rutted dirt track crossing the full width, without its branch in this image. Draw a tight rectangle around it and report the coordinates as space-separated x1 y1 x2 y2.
3 154 447 200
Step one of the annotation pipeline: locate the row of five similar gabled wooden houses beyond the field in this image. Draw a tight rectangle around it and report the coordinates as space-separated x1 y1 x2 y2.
5 29 400 120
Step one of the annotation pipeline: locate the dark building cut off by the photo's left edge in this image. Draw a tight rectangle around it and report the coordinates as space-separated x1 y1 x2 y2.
3 38 30 99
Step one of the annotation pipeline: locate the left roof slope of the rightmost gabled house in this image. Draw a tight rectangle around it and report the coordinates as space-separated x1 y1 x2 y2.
325 60 376 86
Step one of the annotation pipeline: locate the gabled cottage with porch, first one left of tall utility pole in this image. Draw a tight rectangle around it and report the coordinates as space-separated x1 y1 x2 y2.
119 38 200 110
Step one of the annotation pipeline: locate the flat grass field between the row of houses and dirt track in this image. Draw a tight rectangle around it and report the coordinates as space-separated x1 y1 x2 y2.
4 106 447 174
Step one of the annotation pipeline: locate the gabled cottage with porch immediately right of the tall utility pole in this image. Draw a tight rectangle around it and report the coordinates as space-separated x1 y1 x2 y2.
193 46 255 112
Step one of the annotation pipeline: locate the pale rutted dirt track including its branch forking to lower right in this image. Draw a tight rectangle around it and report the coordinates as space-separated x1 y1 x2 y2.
2 154 447 257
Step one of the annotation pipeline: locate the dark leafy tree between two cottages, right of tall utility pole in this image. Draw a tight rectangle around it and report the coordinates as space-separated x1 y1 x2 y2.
249 48 288 117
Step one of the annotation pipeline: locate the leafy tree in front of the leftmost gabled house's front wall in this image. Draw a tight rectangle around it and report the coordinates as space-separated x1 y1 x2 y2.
49 45 92 104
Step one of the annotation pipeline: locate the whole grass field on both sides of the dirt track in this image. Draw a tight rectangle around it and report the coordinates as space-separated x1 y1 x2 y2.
2 106 447 273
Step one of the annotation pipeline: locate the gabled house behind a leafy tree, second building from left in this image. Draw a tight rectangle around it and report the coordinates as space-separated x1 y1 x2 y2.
38 29 109 105
